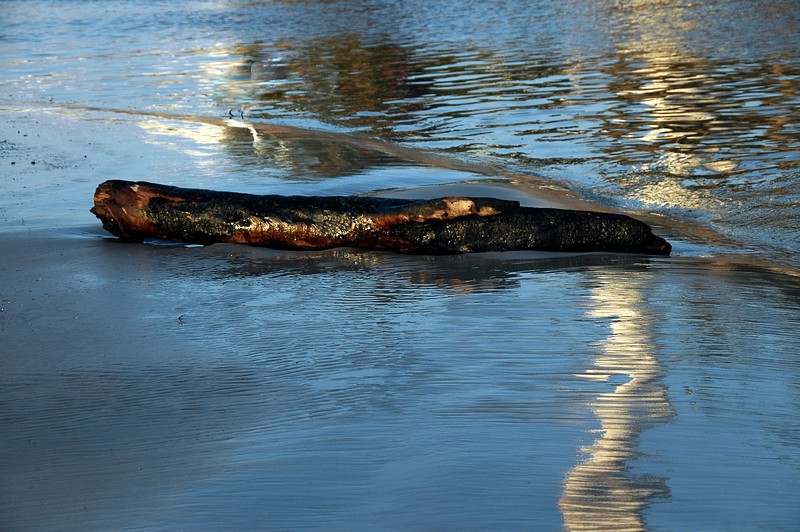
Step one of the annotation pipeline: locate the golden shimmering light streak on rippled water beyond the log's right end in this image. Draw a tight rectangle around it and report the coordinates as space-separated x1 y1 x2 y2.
612 1 738 181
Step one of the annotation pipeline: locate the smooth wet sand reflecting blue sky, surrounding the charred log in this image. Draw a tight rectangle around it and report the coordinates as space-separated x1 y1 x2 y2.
0 111 800 530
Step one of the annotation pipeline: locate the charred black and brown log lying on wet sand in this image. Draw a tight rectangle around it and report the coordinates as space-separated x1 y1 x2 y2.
92 181 671 255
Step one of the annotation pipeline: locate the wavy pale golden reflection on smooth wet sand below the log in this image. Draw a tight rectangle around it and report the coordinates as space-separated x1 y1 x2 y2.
559 272 675 530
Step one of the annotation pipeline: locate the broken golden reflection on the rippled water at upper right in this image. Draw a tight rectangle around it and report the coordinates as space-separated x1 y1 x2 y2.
609 0 739 211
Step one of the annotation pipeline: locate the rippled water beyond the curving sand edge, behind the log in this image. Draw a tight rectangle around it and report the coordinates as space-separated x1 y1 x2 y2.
0 0 800 262
